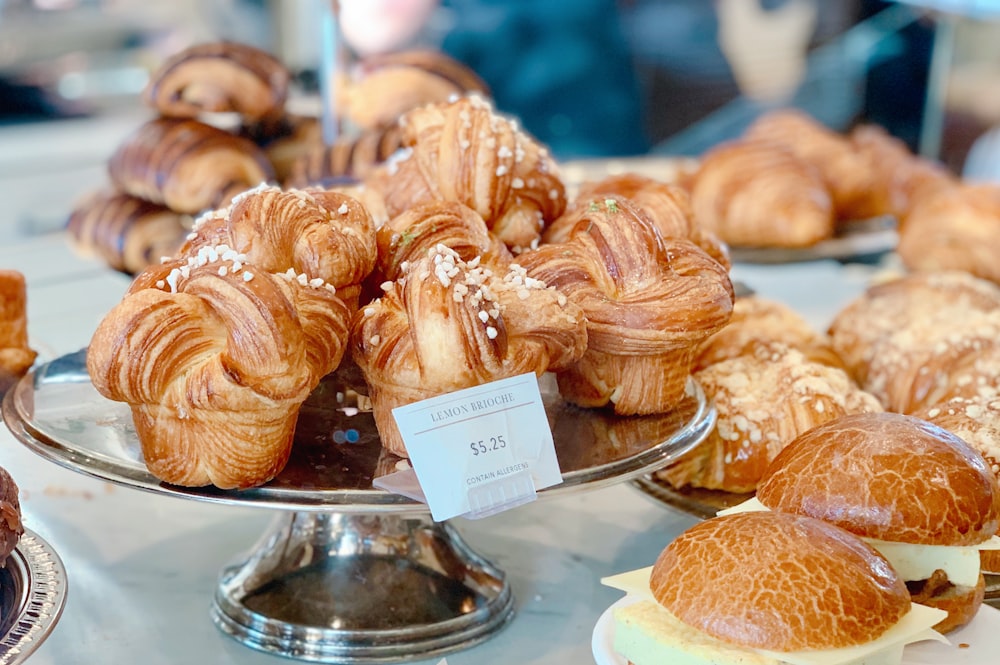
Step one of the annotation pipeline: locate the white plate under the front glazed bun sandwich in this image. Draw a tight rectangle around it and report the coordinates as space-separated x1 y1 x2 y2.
591 598 1000 665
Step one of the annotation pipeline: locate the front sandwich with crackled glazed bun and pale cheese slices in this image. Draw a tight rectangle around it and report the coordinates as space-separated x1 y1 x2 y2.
603 511 944 665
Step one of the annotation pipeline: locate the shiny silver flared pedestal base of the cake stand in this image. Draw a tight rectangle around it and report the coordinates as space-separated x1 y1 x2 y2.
212 511 514 663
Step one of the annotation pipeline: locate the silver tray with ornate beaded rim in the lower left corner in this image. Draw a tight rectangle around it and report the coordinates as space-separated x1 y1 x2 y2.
0 529 66 665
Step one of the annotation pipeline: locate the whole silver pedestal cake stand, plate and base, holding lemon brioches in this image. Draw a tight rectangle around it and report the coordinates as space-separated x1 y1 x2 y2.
3 351 715 663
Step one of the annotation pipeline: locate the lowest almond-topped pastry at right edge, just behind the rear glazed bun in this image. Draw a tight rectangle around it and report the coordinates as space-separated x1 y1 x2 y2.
914 391 1000 575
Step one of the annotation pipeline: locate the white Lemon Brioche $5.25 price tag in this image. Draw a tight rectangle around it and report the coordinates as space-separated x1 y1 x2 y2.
381 373 562 521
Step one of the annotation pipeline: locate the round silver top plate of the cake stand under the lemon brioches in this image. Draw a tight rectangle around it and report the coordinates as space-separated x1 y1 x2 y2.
3 351 715 513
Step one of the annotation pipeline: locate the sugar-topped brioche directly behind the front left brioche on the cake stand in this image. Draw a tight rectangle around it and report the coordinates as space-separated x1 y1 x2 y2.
179 186 377 307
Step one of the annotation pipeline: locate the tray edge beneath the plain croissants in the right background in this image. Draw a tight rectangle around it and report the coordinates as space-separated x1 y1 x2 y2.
729 217 899 263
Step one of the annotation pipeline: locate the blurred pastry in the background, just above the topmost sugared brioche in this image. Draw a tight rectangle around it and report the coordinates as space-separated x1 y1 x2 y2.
338 49 490 130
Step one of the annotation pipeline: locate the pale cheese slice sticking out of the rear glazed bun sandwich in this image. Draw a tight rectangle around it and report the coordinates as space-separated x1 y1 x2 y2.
719 497 1000 586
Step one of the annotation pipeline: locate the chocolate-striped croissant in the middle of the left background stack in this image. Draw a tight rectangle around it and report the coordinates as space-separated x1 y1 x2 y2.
108 118 274 214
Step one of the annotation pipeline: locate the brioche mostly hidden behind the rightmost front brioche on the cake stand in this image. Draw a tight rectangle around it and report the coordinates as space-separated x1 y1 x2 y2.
560 173 732 270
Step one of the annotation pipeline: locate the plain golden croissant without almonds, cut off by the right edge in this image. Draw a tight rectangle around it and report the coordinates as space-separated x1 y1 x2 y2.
896 184 1000 283
